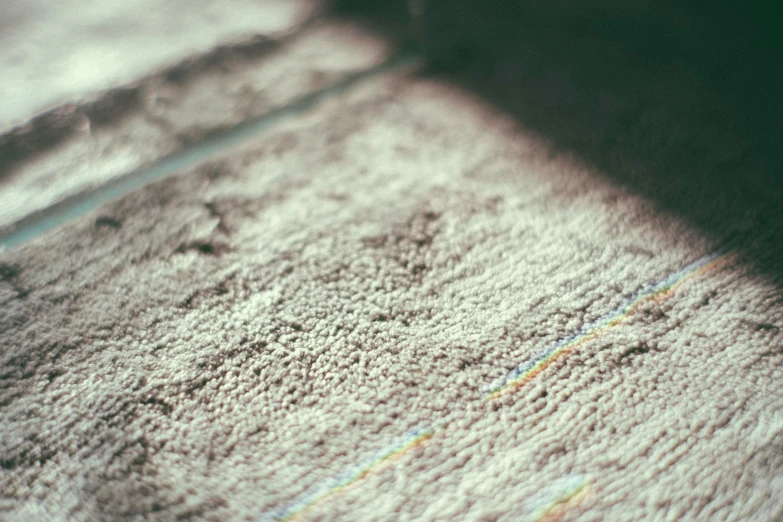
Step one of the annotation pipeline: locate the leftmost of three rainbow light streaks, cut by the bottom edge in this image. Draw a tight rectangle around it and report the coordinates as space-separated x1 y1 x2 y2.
257 428 435 522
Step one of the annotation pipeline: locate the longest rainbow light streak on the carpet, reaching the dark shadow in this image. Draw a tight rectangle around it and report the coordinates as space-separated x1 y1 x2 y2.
486 247 734 400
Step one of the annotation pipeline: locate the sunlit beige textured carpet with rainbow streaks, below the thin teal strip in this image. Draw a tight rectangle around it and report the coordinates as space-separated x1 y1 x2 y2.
0 67 783 520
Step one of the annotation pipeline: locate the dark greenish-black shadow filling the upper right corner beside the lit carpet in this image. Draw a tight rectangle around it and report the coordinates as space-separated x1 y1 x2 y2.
338 0 783 284
